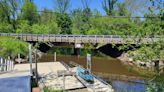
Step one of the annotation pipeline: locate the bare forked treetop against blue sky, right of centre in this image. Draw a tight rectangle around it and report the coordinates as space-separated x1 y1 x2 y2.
102 0 118 16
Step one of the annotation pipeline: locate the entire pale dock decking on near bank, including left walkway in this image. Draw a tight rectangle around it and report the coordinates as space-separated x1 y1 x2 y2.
4 62 114 92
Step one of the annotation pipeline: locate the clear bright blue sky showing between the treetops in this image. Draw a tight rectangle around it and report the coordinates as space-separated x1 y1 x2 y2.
34 0 118 15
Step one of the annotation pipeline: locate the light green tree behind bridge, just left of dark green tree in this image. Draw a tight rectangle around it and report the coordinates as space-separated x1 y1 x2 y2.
38 8 60 34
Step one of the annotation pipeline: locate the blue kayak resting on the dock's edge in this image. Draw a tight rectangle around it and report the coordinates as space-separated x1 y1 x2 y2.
76 67 94 83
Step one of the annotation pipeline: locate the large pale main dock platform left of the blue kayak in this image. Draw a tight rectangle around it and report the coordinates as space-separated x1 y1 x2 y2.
38 62 84 90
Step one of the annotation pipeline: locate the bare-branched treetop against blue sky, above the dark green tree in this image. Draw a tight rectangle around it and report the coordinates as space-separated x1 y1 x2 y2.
54 0 70 13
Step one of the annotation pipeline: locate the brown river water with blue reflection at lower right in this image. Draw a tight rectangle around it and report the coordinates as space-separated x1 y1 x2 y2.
37 54 156 92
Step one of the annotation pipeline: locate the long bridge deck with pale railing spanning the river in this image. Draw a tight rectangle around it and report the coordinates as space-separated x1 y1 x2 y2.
0 33 161 44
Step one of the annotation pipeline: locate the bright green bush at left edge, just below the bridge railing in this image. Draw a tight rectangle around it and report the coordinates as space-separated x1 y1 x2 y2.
0 37 28 58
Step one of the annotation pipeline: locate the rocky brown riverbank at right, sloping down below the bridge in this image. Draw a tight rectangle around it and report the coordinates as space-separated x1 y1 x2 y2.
118 54 164 82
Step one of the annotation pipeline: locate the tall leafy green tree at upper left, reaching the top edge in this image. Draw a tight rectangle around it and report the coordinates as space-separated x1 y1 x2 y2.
20 0 38 25
